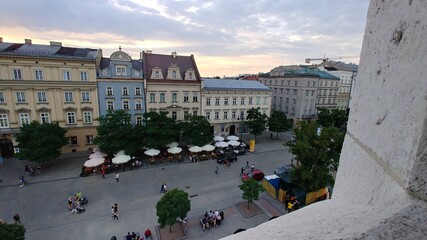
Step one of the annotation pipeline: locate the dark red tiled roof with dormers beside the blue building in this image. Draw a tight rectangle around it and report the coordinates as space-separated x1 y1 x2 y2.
143 52 201 81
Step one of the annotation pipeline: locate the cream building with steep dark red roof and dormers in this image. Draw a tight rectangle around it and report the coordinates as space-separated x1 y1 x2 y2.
143 51 201 121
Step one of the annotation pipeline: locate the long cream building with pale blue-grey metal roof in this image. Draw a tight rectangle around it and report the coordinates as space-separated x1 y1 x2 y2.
202 79 272 135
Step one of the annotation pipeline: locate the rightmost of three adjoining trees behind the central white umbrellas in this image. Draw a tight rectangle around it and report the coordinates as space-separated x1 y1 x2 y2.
182 115 213 146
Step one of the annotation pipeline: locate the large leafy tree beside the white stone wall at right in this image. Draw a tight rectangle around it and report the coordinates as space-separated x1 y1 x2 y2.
286 121 344 191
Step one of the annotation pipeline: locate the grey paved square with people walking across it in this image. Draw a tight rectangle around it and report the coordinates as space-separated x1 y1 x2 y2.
0 133 292 240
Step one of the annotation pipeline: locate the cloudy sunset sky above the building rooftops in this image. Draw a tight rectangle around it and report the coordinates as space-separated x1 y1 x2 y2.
0 0 369 76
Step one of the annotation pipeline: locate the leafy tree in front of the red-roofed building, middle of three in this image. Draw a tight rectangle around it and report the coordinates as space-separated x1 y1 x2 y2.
144 111 181 148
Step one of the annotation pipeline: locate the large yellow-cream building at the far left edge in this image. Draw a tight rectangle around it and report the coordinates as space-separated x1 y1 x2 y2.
0 38 102 156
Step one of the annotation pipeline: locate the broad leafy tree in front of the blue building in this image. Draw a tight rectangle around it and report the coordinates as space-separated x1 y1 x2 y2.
93 110 143 154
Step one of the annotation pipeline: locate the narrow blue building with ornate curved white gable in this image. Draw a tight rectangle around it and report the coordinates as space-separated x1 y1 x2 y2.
97 48 145 124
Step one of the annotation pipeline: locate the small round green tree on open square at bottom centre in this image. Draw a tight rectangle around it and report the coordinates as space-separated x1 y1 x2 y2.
156 188 191 232
